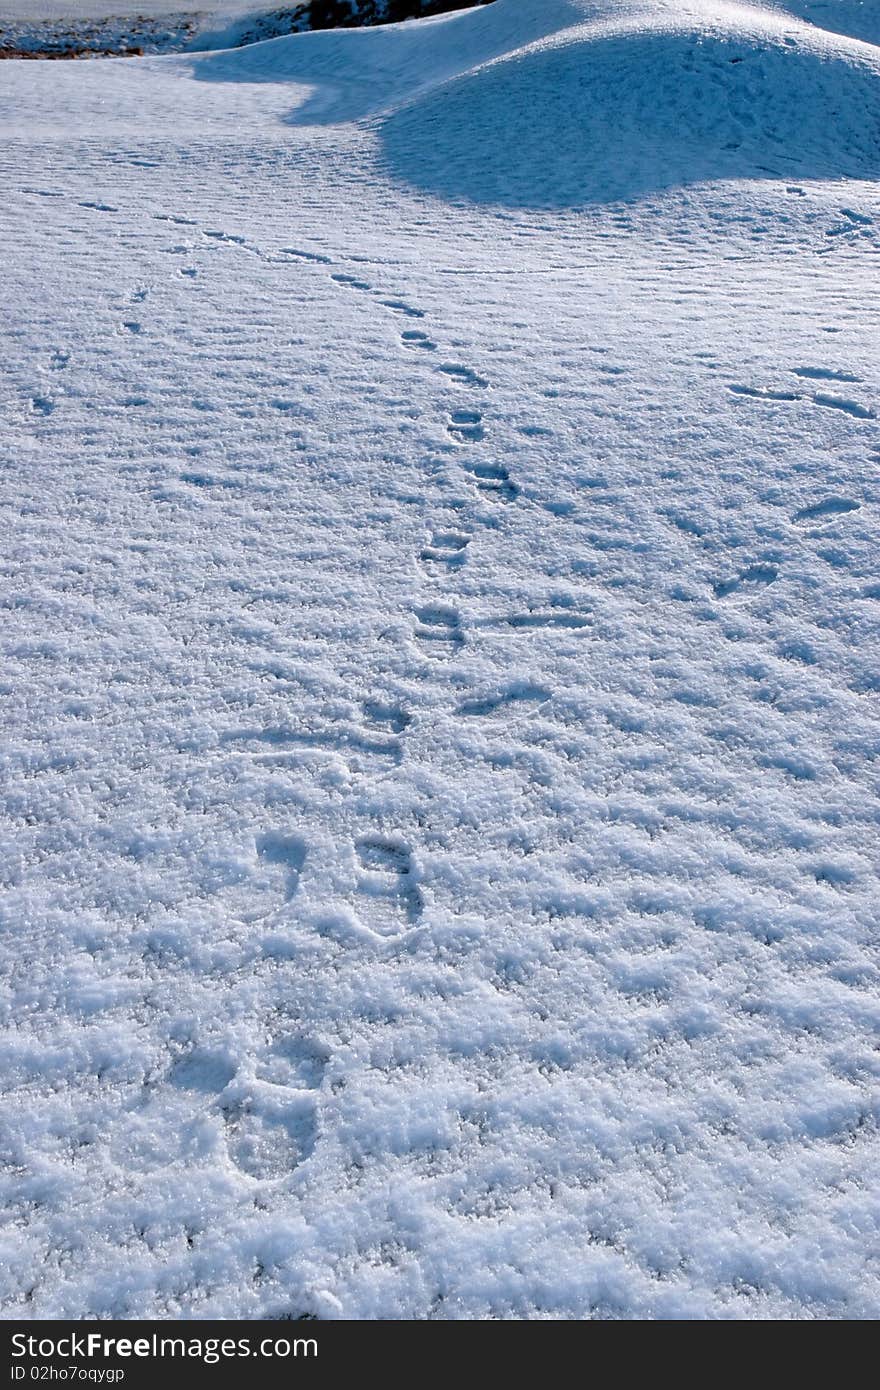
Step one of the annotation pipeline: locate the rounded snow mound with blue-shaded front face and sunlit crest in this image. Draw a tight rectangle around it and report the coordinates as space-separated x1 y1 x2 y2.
382 10 880 207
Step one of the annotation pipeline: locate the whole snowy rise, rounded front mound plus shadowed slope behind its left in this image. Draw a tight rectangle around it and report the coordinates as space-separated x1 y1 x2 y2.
196 0 880 207
